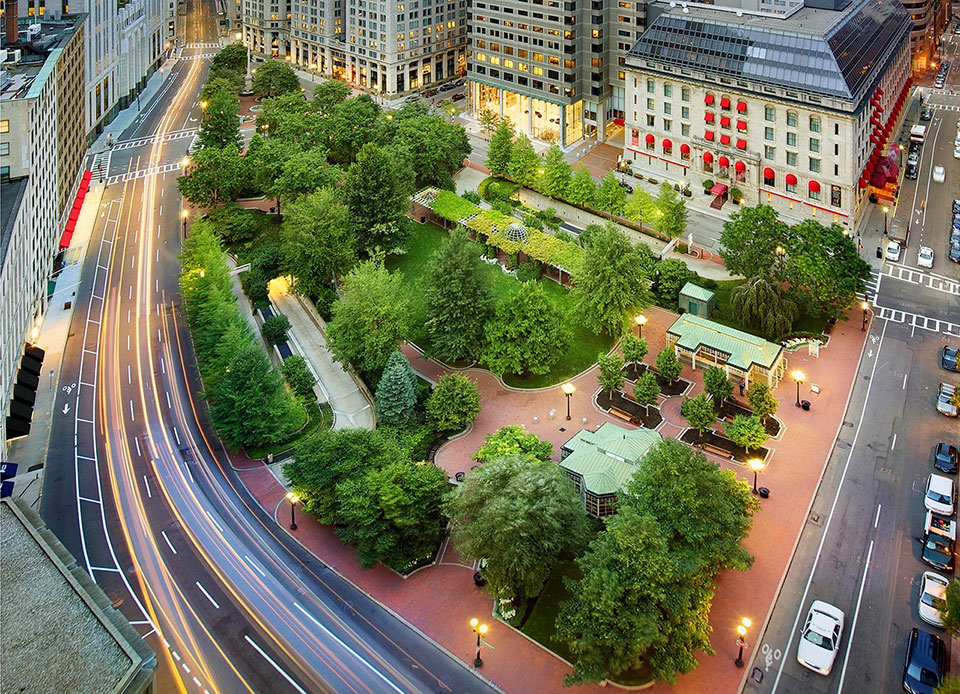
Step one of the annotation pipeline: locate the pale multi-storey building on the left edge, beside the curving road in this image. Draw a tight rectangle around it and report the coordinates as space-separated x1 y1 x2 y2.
0 14 87 450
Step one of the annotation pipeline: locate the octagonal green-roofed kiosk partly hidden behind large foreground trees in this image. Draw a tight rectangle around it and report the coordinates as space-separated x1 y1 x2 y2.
559 422 663 518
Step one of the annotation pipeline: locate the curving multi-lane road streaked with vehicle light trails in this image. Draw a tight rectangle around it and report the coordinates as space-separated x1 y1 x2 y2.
42 0 493 694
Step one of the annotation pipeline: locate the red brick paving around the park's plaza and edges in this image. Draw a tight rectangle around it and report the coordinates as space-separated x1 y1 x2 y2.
238 308 867 694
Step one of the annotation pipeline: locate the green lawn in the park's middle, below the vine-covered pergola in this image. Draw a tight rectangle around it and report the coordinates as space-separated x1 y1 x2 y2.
387 222 613 388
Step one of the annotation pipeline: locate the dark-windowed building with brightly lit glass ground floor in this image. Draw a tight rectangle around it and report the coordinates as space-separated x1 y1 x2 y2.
467 0 646 147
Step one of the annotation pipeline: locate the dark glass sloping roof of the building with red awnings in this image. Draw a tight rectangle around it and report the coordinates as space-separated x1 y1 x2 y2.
627 0 912 101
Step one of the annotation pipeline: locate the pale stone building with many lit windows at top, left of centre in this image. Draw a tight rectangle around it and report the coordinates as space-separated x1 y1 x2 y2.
244 0 467 98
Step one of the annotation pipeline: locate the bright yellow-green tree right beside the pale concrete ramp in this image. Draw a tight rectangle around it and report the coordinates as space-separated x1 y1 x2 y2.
327 260 409 374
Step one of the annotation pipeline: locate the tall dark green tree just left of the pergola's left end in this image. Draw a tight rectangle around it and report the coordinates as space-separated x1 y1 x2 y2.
343 143 413 253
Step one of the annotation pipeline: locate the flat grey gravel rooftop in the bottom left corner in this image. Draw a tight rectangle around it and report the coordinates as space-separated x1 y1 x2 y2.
0 499 156 694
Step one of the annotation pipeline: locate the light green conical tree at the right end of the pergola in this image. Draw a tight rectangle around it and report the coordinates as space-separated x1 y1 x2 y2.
571 222 651 337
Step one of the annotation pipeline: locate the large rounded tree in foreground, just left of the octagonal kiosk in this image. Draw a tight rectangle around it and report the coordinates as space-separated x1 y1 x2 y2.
447 456 588 602
